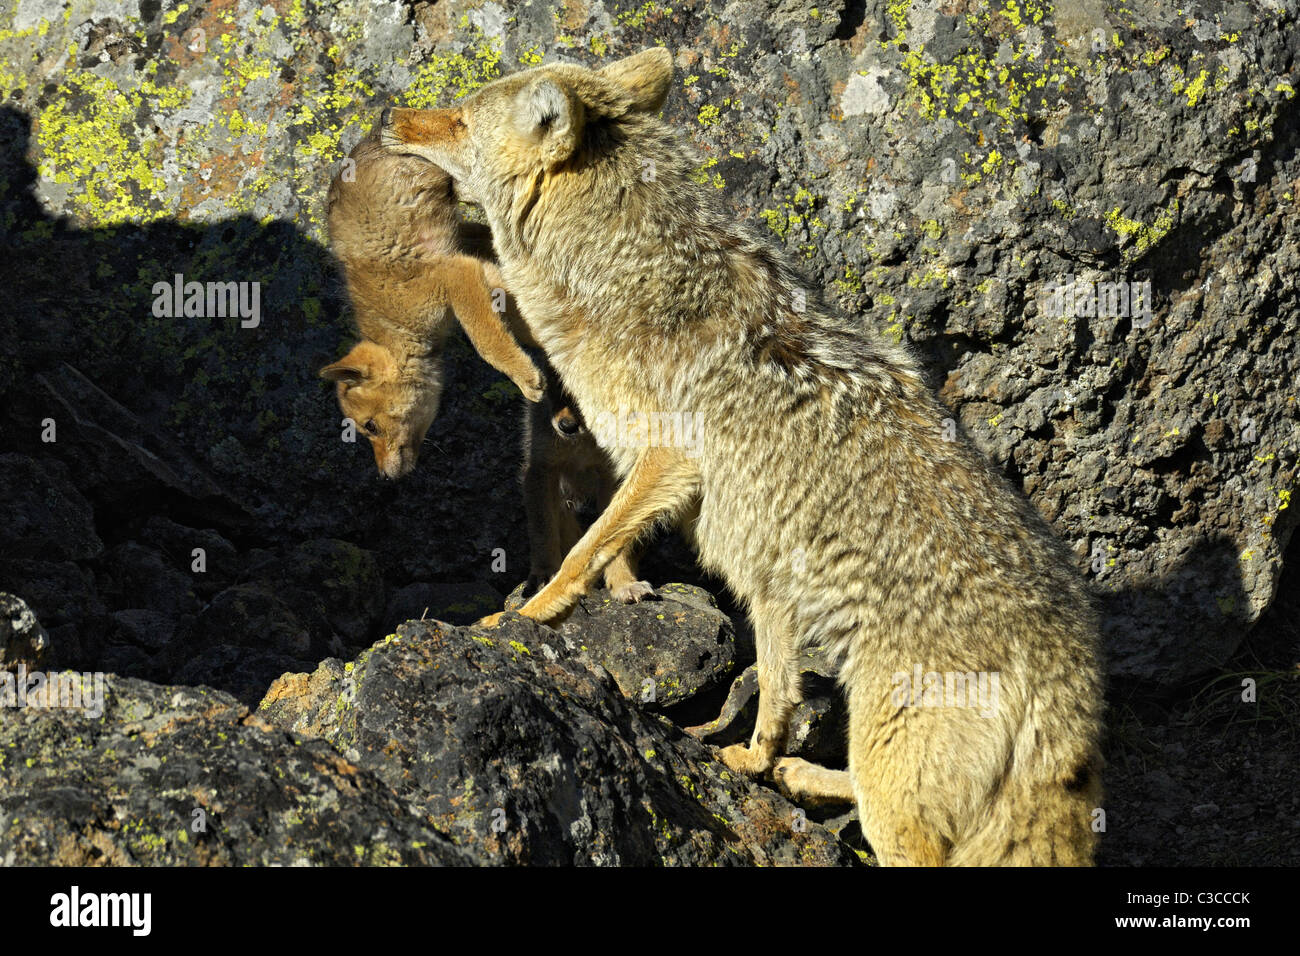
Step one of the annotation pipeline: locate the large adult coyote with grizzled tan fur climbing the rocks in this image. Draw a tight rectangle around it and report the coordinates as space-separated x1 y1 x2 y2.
384 49 1102 865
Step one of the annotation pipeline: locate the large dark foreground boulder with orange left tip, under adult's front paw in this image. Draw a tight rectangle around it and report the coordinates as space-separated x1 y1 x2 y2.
259 615 855 865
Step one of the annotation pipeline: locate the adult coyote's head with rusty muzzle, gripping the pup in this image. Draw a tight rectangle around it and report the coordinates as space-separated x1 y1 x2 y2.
381 47 672 216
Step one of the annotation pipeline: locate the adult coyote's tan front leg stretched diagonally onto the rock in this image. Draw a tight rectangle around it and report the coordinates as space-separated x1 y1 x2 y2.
478 447 699 627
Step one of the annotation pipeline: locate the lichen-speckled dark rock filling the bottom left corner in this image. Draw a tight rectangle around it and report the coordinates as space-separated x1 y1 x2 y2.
0 676 468 866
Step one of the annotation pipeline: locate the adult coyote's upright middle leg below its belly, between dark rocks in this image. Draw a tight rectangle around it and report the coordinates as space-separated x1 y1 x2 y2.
720 613 803 777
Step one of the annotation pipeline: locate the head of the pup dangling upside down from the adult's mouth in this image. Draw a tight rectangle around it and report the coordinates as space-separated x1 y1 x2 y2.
320 342 442 479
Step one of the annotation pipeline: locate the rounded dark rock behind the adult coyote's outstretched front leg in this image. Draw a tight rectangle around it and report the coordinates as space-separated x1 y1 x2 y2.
555 584 736 708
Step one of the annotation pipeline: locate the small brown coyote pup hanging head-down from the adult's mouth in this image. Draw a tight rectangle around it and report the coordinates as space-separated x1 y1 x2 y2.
320 128 545 479
